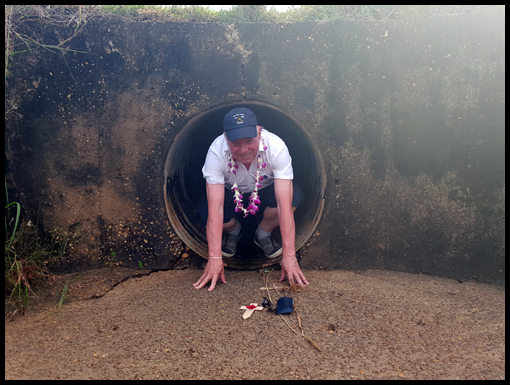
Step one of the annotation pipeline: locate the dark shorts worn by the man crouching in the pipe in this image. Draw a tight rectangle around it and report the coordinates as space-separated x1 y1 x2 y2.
197 182 304 226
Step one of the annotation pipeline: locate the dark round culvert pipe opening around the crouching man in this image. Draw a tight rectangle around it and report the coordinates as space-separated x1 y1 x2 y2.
164 101 326 269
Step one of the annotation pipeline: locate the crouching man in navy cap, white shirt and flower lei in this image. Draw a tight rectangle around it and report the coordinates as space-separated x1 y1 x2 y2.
193 108 308 291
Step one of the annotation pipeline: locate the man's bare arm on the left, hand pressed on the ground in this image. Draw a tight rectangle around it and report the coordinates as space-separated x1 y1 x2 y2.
193 183 227 291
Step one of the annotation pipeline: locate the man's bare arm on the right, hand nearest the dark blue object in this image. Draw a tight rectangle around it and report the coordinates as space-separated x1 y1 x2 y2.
274 179 308 286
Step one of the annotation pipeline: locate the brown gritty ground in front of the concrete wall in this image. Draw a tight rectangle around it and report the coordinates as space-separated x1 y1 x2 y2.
5 268 505 380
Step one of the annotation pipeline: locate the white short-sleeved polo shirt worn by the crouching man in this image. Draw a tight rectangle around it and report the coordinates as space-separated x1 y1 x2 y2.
202 128 294 193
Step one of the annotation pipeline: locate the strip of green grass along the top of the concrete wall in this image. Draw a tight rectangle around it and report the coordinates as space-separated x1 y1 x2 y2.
5 5 504 26
